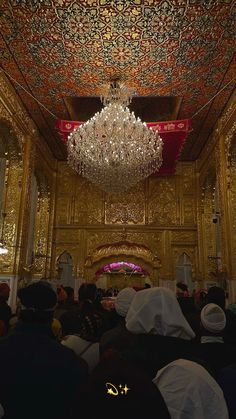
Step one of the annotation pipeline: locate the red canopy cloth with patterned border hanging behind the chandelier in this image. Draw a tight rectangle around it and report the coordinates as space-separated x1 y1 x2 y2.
56 119 191 176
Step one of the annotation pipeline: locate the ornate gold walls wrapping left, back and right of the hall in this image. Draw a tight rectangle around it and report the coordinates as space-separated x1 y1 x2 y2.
0 72 236 300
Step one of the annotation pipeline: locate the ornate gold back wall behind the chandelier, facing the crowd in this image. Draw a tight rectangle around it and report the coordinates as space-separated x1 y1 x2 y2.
53 162 198 283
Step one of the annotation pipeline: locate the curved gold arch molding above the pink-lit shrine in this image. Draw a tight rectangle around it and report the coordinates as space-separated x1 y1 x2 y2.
84 241 161 279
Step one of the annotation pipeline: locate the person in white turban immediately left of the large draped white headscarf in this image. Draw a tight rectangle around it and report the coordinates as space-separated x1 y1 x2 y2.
100 287 136 356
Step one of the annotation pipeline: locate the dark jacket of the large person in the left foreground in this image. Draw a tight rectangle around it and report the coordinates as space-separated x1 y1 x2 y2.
0 323 87 419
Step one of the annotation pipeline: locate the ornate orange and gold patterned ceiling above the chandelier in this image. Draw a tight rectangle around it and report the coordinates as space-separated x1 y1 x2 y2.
0 0 236 159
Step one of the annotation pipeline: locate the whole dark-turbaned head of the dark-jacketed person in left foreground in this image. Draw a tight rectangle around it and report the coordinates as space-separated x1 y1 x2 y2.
17 281 57 323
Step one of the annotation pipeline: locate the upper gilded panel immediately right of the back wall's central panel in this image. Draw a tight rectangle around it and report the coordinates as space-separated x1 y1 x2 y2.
148 176 178 226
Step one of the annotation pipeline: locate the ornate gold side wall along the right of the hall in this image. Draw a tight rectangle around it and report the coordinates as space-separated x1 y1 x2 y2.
196 89 236 301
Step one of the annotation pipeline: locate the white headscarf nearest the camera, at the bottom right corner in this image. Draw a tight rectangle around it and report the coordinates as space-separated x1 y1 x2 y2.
152 359 229 419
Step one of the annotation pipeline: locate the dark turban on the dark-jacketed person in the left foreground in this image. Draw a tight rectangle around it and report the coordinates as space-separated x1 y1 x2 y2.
18 281 57 311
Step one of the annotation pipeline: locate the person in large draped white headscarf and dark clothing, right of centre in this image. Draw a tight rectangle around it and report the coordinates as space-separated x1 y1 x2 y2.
110 287 195 378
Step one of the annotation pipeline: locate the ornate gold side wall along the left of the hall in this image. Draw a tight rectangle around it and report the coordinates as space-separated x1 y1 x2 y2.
0 71 56 305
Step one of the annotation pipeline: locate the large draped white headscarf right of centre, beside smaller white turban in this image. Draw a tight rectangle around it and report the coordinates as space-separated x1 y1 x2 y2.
126 287 195 340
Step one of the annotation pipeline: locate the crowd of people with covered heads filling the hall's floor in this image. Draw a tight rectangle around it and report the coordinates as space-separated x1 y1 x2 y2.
0 280 236 419
